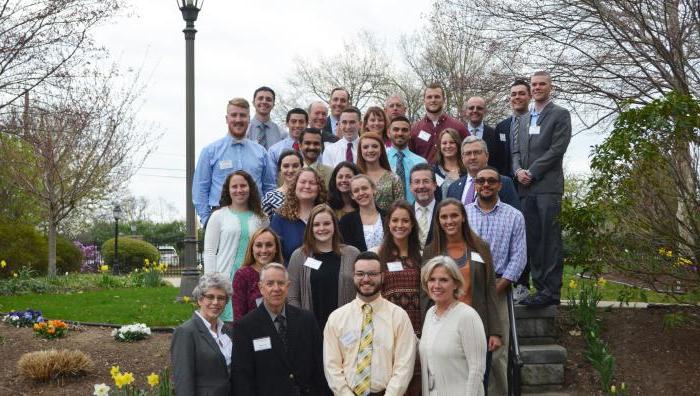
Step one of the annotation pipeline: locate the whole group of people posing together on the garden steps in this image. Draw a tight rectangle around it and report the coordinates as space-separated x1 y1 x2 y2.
171 72 571 396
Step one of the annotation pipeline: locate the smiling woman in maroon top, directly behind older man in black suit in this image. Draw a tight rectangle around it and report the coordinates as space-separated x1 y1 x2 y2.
231 227 282 321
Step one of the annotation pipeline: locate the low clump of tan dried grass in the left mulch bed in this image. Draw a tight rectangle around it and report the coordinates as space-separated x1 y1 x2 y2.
17 349 94 381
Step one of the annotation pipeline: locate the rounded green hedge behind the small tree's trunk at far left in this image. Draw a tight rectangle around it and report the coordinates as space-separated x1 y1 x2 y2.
0 223 83 277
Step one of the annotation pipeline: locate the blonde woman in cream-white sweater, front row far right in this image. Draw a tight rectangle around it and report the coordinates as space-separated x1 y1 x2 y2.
418 256 486 396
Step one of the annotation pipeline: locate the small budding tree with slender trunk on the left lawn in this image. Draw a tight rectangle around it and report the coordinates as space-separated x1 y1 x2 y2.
0 68 151 275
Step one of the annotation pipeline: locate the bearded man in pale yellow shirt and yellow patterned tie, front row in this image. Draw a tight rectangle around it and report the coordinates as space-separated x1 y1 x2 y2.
323 252 416 396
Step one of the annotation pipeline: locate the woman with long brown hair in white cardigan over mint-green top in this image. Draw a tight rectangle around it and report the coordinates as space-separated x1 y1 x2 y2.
203 170 267 322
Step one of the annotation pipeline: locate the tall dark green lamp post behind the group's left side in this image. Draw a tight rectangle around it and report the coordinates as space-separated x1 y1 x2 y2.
177 0 204 298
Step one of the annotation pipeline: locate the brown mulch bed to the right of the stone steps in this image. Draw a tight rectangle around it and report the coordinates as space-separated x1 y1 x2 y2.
558 306 700 395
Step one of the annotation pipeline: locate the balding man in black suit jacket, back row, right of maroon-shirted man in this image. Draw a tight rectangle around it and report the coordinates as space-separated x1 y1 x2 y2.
462 96 509 175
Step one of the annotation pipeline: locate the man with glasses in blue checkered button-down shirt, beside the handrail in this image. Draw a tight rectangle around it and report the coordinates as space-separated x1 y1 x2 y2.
466 166 527 395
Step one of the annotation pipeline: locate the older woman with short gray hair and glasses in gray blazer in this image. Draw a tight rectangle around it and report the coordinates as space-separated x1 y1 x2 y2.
170 272 232 396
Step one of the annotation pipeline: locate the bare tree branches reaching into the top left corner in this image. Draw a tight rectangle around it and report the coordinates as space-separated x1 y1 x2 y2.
0 0 123 110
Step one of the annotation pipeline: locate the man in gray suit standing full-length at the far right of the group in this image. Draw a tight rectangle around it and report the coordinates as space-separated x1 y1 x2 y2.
513 71 571 306
